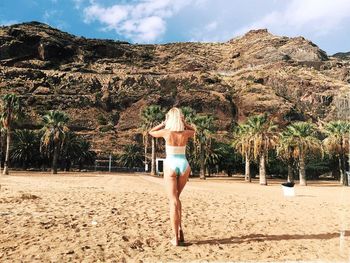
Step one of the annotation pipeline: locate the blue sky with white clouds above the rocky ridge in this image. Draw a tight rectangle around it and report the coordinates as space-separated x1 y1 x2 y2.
0 0 350 55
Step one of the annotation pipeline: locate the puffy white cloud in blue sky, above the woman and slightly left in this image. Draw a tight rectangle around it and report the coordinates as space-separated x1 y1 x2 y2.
81 0 207 43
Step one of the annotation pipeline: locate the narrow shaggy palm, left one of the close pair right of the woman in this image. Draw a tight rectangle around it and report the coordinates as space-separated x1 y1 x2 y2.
232 124 253 182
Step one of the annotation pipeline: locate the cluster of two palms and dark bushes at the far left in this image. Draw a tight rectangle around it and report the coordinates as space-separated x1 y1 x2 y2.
0 94 96 175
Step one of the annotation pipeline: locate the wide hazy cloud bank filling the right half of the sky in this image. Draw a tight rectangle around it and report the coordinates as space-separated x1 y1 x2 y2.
187 0 350 45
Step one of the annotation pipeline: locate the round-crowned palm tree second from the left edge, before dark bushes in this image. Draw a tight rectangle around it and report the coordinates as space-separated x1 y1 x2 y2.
41 110 69 174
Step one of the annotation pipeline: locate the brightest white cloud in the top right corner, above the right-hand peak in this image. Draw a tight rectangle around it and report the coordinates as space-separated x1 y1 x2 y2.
236 0 350 35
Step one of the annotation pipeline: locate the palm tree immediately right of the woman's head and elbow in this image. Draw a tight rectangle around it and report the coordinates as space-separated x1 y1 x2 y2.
193 115 216 179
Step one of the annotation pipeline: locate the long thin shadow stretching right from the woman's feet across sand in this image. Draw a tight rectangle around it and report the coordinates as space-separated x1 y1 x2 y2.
186 230 350 246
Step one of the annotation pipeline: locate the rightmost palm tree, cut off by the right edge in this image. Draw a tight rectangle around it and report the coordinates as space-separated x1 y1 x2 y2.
322 121 350 186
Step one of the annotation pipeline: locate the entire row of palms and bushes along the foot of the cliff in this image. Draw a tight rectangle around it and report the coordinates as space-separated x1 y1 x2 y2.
0 94 350 185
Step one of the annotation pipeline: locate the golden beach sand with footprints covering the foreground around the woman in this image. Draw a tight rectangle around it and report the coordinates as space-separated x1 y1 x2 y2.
0 172 350 262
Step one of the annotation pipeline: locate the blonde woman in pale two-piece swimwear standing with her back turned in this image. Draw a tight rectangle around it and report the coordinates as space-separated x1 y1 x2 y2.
149 107 195 246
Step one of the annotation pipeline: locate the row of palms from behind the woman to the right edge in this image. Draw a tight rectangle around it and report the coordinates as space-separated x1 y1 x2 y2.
141 105 350 185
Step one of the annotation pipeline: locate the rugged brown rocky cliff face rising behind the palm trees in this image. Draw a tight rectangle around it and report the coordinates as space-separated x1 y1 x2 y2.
0 22 350 155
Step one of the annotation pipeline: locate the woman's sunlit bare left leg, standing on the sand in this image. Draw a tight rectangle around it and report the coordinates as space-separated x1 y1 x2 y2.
164 169 180 245
